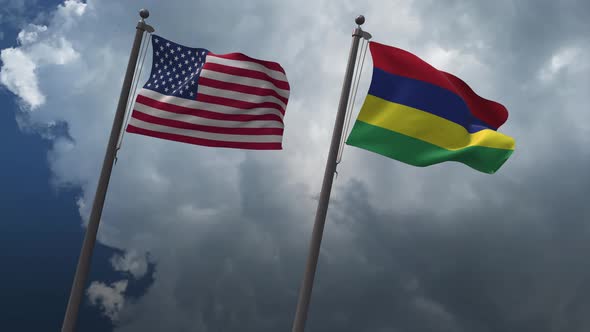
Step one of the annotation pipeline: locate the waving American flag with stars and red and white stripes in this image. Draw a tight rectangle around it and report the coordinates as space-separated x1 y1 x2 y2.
127 35 289 150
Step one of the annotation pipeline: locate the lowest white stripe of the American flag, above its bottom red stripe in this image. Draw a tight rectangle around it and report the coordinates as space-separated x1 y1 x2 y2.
129 118 282 143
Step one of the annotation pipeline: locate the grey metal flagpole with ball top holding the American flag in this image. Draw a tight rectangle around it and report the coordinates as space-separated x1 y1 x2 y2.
61 9 154 332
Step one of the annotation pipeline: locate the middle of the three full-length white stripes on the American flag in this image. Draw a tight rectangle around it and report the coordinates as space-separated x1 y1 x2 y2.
133 103 284 128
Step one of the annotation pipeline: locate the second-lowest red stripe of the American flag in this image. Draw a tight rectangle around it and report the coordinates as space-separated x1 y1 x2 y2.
131 110 283 135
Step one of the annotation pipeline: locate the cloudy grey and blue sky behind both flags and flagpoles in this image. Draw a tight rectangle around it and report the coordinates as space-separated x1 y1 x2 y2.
0 0 590 332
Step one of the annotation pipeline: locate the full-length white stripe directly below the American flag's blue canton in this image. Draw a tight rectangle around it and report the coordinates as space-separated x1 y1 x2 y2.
139 89 283 119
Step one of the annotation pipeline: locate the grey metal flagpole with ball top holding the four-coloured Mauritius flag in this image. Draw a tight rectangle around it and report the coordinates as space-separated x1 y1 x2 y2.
292 15 370 332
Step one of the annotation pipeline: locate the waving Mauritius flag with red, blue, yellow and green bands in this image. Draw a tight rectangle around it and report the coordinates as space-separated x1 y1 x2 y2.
346 42 514 173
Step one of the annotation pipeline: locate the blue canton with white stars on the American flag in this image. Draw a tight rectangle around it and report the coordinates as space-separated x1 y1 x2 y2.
144 35 209 100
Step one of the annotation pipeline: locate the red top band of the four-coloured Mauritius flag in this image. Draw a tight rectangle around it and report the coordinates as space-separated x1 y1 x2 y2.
369 42 508 128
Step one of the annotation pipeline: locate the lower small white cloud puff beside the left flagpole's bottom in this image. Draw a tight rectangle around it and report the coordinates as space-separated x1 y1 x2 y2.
86 280 127 320
